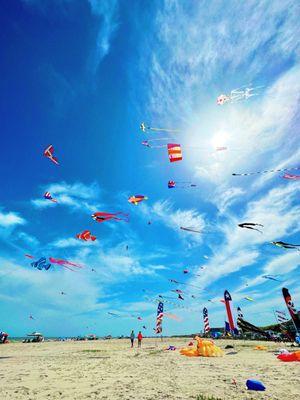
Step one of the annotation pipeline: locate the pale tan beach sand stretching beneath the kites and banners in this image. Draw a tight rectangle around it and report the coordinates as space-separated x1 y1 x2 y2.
0 338 300 400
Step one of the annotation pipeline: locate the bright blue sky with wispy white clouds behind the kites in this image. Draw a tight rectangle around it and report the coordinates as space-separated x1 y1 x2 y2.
0 0 300 336
